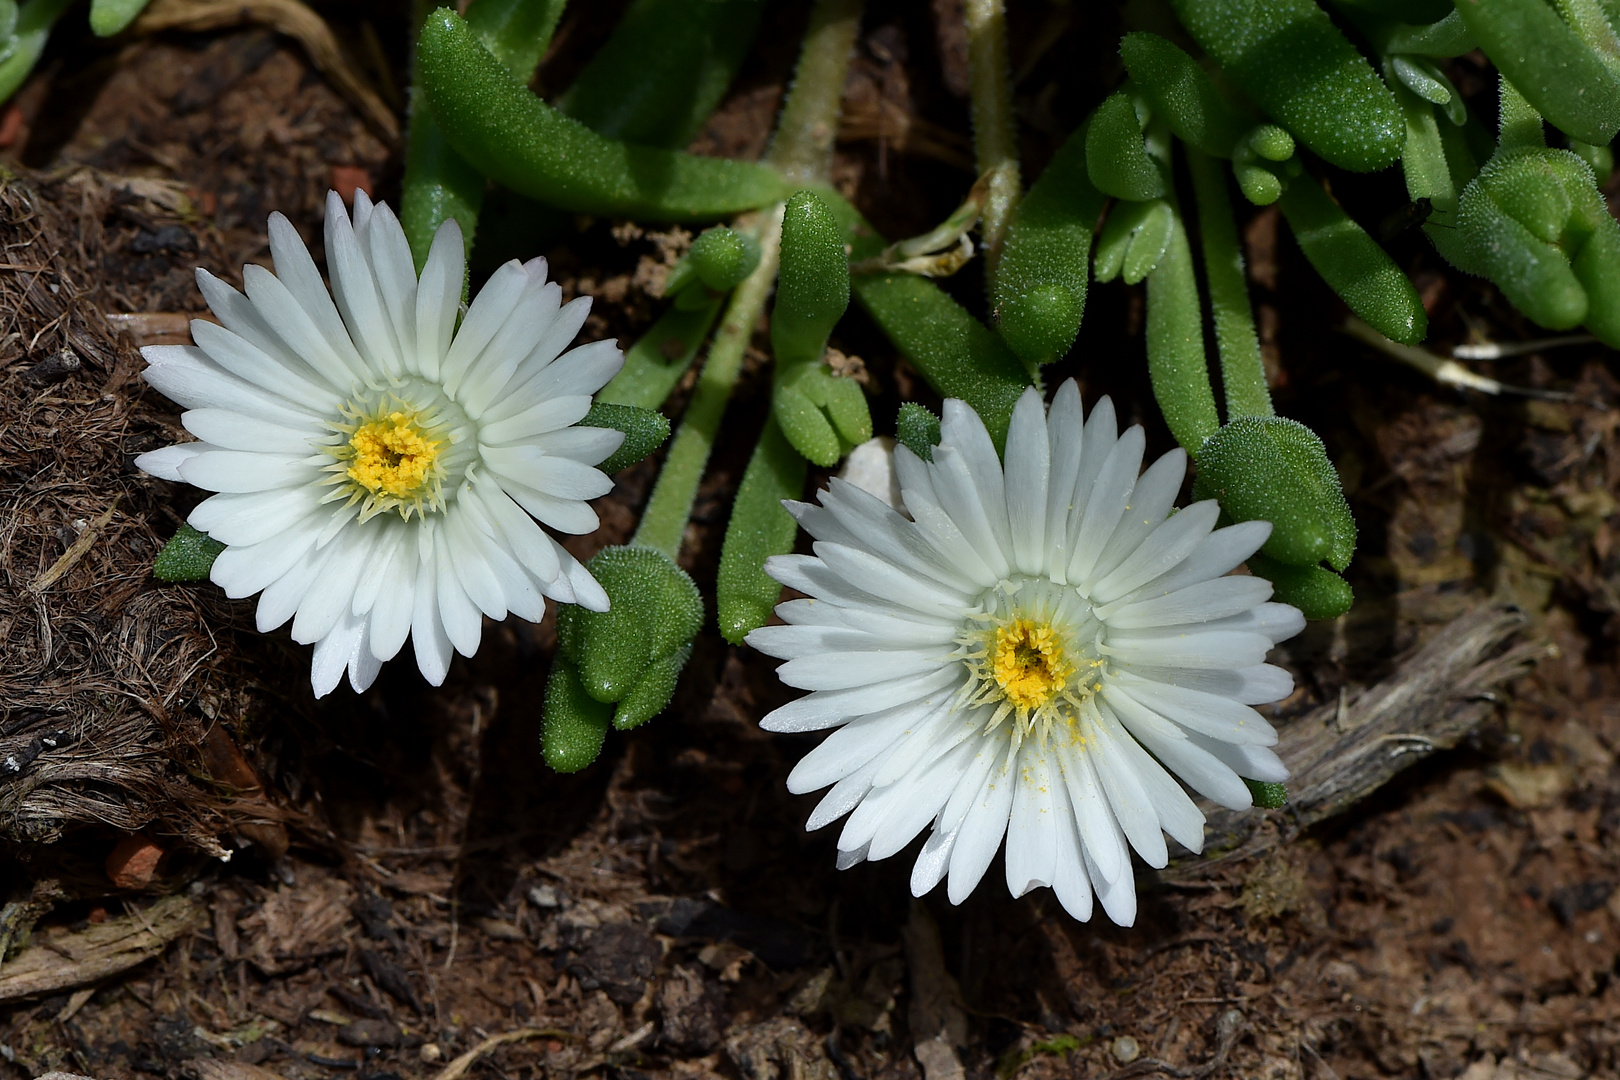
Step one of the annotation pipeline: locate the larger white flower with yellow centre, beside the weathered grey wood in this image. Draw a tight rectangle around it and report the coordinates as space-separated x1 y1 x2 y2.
748 382 1304 926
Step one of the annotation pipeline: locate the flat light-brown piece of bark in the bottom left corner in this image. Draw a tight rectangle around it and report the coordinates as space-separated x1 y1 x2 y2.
0 895 207 1002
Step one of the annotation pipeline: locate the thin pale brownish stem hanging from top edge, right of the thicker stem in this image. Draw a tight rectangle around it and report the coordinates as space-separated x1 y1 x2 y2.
964 0 1022 287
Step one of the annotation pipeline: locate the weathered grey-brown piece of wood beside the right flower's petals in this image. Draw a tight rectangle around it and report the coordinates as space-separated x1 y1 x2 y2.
1158 602 1544 881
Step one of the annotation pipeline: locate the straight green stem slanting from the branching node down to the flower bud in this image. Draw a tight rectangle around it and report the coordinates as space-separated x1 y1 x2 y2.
630 215 782 559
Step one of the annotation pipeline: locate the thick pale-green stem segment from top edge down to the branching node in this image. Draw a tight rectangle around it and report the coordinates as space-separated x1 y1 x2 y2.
765 0 867 185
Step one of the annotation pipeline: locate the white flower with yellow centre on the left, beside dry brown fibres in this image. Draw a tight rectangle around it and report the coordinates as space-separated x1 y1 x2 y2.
136 193 624 696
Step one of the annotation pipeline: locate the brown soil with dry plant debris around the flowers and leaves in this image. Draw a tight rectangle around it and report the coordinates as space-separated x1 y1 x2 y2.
0 0 1620 1080
